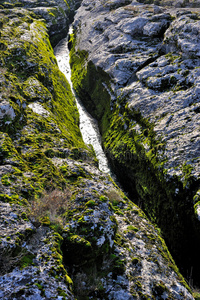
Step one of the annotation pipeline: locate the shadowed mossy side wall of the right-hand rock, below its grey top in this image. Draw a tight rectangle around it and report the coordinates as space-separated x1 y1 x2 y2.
71 28 199 288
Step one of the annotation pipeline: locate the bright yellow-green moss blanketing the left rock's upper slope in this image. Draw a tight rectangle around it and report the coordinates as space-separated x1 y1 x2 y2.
0 10 94 204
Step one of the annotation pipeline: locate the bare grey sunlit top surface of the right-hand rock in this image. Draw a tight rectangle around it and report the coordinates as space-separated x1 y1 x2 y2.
74 1 200 180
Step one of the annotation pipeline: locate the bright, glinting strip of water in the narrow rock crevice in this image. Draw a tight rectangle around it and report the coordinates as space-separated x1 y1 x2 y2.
54 31 111 174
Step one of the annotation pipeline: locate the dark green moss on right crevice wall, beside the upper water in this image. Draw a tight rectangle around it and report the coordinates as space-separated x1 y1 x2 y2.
70 37 110 132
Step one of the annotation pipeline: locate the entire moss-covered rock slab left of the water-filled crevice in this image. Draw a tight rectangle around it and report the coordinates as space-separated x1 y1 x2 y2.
0 1 198 300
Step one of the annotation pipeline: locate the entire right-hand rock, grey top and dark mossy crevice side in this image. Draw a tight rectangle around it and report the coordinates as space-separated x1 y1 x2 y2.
71 0 200 284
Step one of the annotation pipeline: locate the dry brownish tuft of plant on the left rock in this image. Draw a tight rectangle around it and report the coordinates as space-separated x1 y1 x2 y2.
29 189 71 226
